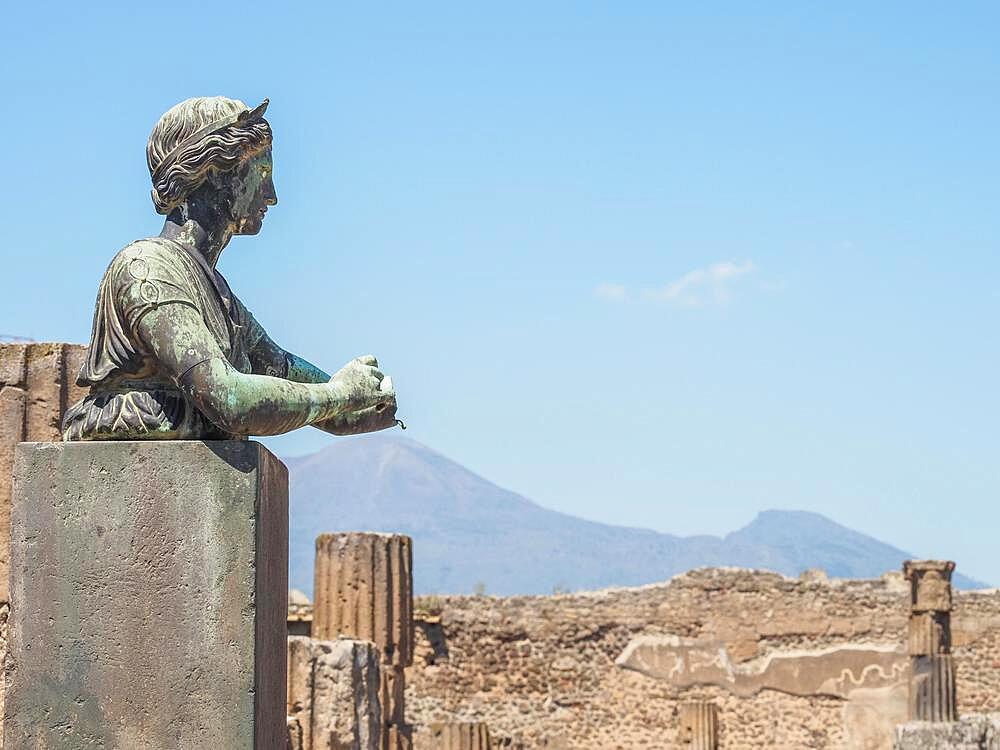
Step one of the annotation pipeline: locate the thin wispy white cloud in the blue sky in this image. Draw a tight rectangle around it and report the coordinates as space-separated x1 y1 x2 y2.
594 261 756 307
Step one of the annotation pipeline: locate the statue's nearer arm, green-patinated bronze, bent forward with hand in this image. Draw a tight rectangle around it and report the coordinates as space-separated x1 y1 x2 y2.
137 303 382 435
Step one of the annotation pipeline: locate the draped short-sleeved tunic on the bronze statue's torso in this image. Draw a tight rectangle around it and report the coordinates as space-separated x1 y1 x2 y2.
63 237 264 440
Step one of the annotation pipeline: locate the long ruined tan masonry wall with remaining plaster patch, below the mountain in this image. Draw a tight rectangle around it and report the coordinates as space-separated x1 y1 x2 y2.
406 569 1000 750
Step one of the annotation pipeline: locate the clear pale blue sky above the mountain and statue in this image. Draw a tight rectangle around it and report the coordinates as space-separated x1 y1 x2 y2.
0 2 1000 583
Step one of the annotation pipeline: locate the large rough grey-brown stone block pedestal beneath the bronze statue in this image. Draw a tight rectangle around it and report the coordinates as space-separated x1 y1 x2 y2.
4 441 288 750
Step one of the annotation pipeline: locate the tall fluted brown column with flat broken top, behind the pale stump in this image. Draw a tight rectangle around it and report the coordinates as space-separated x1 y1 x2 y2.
312 532 414 750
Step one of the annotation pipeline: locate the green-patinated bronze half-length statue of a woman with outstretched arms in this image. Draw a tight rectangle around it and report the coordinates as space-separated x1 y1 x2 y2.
63 96 396 440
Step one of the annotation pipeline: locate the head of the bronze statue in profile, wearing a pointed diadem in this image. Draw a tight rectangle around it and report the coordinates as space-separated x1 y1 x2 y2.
146 96 278 234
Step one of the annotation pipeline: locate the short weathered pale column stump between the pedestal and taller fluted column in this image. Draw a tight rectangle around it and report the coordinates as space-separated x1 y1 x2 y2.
287 636 383 750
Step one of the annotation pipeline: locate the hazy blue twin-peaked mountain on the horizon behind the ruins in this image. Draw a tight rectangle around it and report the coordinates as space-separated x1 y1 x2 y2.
285 433 984 595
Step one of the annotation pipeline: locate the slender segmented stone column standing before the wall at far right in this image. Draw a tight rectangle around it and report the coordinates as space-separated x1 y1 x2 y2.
903 560 958 722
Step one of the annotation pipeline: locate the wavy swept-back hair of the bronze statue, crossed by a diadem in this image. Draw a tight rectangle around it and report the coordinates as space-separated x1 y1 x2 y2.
146 96 271 214
